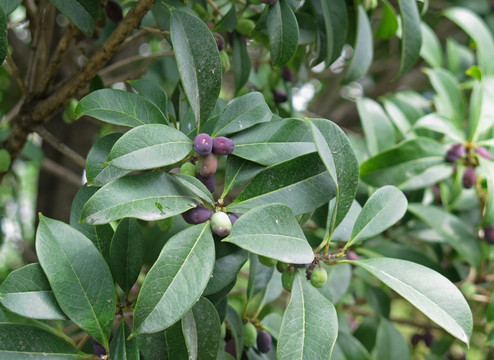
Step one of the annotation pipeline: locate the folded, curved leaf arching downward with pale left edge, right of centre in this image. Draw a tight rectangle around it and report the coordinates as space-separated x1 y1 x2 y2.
309 119 359 232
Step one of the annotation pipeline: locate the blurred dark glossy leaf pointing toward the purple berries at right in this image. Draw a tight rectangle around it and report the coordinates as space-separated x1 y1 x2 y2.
360 137 446 187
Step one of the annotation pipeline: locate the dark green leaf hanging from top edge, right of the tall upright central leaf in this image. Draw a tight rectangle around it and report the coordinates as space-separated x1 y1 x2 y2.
267 0 299 66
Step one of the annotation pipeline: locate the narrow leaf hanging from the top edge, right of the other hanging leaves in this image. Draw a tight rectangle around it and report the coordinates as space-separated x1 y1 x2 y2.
397 0 422 76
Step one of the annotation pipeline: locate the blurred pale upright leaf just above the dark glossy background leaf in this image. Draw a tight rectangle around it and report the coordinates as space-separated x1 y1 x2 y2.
357 98 395 156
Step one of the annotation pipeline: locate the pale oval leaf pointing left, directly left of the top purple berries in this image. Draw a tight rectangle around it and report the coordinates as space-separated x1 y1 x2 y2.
105 124 192 170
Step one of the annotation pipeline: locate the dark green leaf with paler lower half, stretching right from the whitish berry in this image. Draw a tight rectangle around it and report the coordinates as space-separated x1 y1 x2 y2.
227 153 335 215
